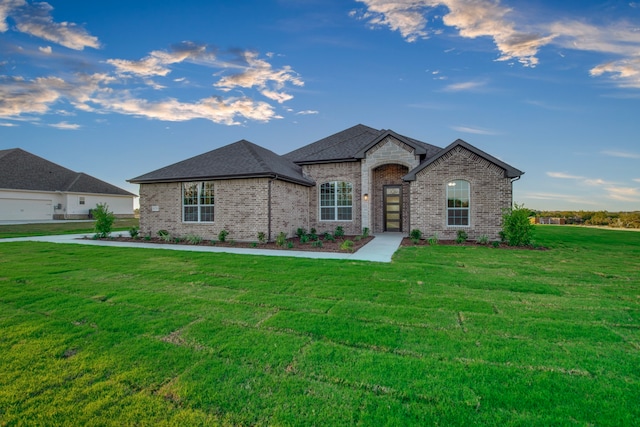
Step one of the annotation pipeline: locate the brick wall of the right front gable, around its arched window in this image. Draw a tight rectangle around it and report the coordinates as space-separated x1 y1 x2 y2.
410 147 512 240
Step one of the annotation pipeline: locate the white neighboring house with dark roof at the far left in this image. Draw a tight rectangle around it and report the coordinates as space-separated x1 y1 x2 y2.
0 148 136 220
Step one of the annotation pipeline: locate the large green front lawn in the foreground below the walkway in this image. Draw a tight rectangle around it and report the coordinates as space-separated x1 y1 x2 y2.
0 226 640 426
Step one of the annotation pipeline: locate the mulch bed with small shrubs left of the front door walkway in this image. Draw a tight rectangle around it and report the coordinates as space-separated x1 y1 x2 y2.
86 236 373 253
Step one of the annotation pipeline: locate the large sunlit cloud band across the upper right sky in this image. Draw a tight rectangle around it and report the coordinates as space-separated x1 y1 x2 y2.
350 0 640 88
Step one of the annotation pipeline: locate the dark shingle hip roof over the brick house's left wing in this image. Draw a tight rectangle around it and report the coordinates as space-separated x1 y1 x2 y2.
129 140 314 186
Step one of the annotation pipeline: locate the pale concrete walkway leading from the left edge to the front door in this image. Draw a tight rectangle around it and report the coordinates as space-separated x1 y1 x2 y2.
0 231 404 262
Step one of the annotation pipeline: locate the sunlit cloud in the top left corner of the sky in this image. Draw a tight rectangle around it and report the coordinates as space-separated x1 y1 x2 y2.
7 0 100 50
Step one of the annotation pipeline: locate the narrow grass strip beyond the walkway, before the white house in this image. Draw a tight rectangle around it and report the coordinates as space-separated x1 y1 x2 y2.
0 218 140 239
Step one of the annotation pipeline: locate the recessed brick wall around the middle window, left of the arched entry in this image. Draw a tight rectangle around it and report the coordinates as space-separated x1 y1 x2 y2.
302 162 362 235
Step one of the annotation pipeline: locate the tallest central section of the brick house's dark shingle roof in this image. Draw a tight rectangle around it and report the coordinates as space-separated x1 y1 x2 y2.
285 125 441 164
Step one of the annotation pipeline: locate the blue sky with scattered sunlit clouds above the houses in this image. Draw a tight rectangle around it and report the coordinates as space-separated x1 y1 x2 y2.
0 0 640 211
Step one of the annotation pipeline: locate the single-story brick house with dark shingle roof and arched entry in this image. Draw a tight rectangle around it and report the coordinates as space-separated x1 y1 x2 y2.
130 125 523 241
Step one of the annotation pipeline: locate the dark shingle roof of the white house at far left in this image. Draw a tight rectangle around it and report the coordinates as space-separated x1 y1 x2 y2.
0 148 134 196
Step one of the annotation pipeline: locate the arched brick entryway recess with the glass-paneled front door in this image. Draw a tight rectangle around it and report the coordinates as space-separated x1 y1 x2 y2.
371 164 409 233
